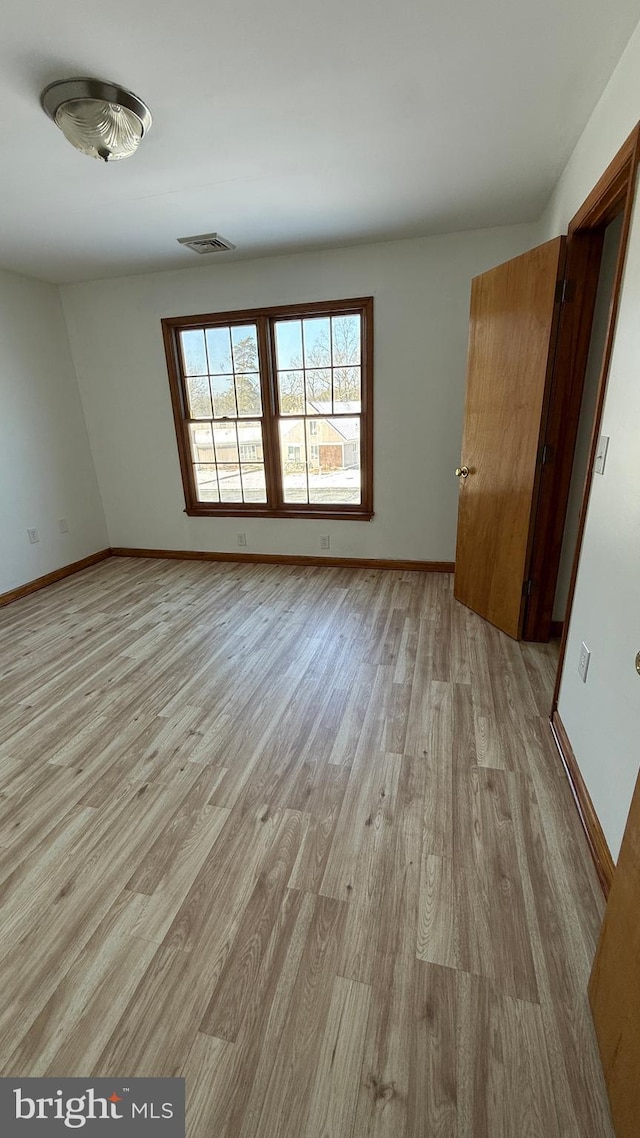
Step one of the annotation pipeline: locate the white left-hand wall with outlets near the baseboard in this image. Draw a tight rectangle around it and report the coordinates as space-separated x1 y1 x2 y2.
0 262 108 593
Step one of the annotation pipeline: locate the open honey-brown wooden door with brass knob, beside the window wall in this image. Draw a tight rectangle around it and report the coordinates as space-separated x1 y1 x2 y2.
454 237 565 638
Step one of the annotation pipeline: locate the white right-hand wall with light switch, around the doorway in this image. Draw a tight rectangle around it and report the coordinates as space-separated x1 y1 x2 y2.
544 17 640 857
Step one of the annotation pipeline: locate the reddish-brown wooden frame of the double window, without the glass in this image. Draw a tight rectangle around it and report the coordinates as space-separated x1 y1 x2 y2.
162 296 374 521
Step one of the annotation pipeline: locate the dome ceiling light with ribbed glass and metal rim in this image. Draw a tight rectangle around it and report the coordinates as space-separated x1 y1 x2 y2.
40 79 151 162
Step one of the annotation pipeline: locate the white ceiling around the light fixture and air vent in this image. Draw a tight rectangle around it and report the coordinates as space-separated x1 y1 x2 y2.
0 0 640 281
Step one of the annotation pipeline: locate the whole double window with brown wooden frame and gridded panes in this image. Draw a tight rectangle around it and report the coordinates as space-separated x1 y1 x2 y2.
162 297 374 519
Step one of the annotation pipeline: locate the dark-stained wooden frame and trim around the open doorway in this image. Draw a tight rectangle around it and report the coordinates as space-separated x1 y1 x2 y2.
523 123 640 646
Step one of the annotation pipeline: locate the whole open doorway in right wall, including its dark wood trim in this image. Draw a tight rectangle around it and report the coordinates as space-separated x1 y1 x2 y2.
523 124 640 646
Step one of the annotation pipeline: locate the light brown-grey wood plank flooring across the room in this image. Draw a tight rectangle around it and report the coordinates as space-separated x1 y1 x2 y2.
0 558 612 1138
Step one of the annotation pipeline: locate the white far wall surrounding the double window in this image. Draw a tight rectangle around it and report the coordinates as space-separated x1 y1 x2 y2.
61 226 534 561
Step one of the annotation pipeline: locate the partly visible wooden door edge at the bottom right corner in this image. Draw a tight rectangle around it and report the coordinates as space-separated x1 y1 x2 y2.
589 777 640 1138
